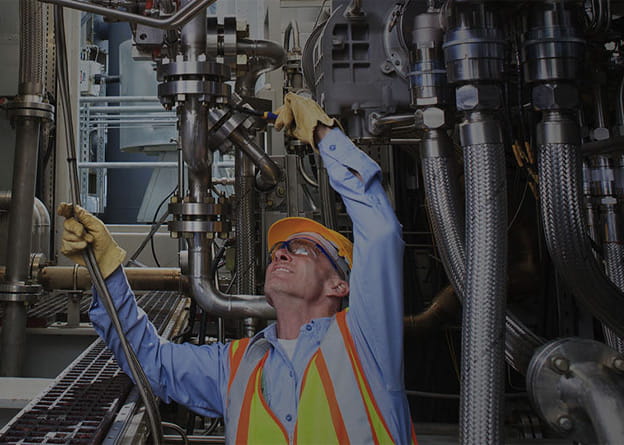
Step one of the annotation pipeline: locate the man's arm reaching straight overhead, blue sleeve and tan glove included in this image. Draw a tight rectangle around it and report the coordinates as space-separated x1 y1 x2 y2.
275 93 404 390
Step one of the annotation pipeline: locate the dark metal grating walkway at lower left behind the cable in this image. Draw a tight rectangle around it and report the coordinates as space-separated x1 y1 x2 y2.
0 291 181 445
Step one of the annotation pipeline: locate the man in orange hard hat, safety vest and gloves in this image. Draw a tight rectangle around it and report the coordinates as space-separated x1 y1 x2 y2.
59 93 416 445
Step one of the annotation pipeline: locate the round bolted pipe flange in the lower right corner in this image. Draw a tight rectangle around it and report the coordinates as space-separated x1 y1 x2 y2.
526 338 622 442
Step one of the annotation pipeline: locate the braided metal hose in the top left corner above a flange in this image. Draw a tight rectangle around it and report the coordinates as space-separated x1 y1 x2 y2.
19 0 44 95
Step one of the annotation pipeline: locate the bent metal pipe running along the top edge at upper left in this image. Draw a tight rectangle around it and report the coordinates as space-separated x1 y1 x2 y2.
41 0 216 30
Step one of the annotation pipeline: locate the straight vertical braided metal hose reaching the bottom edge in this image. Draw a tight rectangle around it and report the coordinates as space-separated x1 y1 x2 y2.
460 138 507 444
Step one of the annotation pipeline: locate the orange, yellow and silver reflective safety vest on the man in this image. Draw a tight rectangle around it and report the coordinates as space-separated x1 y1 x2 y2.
225 311 417 445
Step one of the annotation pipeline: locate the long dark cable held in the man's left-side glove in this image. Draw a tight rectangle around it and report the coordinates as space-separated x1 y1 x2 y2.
54 6 163 445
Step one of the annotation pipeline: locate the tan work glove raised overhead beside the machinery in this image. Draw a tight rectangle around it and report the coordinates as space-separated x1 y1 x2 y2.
275 93 342 148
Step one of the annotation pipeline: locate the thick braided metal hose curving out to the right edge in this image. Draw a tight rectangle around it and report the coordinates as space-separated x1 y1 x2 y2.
538 139 624 336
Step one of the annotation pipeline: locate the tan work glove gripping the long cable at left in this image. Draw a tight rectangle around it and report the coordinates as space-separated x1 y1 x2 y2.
57 202 126 278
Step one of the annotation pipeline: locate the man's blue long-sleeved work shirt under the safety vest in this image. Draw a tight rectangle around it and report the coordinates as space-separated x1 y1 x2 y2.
90 129 411 443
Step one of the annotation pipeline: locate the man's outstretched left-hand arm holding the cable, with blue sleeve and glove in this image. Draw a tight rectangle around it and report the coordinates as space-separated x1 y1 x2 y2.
59 206 229 417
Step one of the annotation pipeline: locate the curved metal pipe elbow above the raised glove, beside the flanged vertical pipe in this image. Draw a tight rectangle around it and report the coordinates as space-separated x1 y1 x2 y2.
236 39 286 96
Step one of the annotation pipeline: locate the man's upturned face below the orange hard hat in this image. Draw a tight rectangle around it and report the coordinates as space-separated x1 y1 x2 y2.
264 235 336 306
